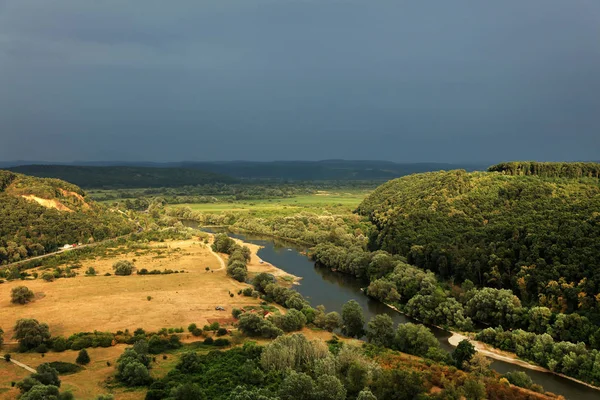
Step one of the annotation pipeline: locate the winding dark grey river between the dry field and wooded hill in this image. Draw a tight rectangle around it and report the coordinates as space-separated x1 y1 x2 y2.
195 227 600 400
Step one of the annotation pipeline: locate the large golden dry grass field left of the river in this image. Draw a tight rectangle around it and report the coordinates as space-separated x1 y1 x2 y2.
0 240 285 341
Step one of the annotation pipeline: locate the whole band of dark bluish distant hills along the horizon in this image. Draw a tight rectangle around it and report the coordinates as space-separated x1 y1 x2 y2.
0 160 487 184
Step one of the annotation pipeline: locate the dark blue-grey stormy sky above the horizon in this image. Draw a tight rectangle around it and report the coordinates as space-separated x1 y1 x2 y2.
0 0 600 162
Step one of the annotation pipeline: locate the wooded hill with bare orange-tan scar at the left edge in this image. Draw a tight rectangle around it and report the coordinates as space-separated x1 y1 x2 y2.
0 170 134 265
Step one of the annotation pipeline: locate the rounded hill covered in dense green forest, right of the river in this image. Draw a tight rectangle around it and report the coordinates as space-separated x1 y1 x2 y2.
358 164 600 315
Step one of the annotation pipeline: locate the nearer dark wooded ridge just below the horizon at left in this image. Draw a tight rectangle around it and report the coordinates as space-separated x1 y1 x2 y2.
10 165 237 188
